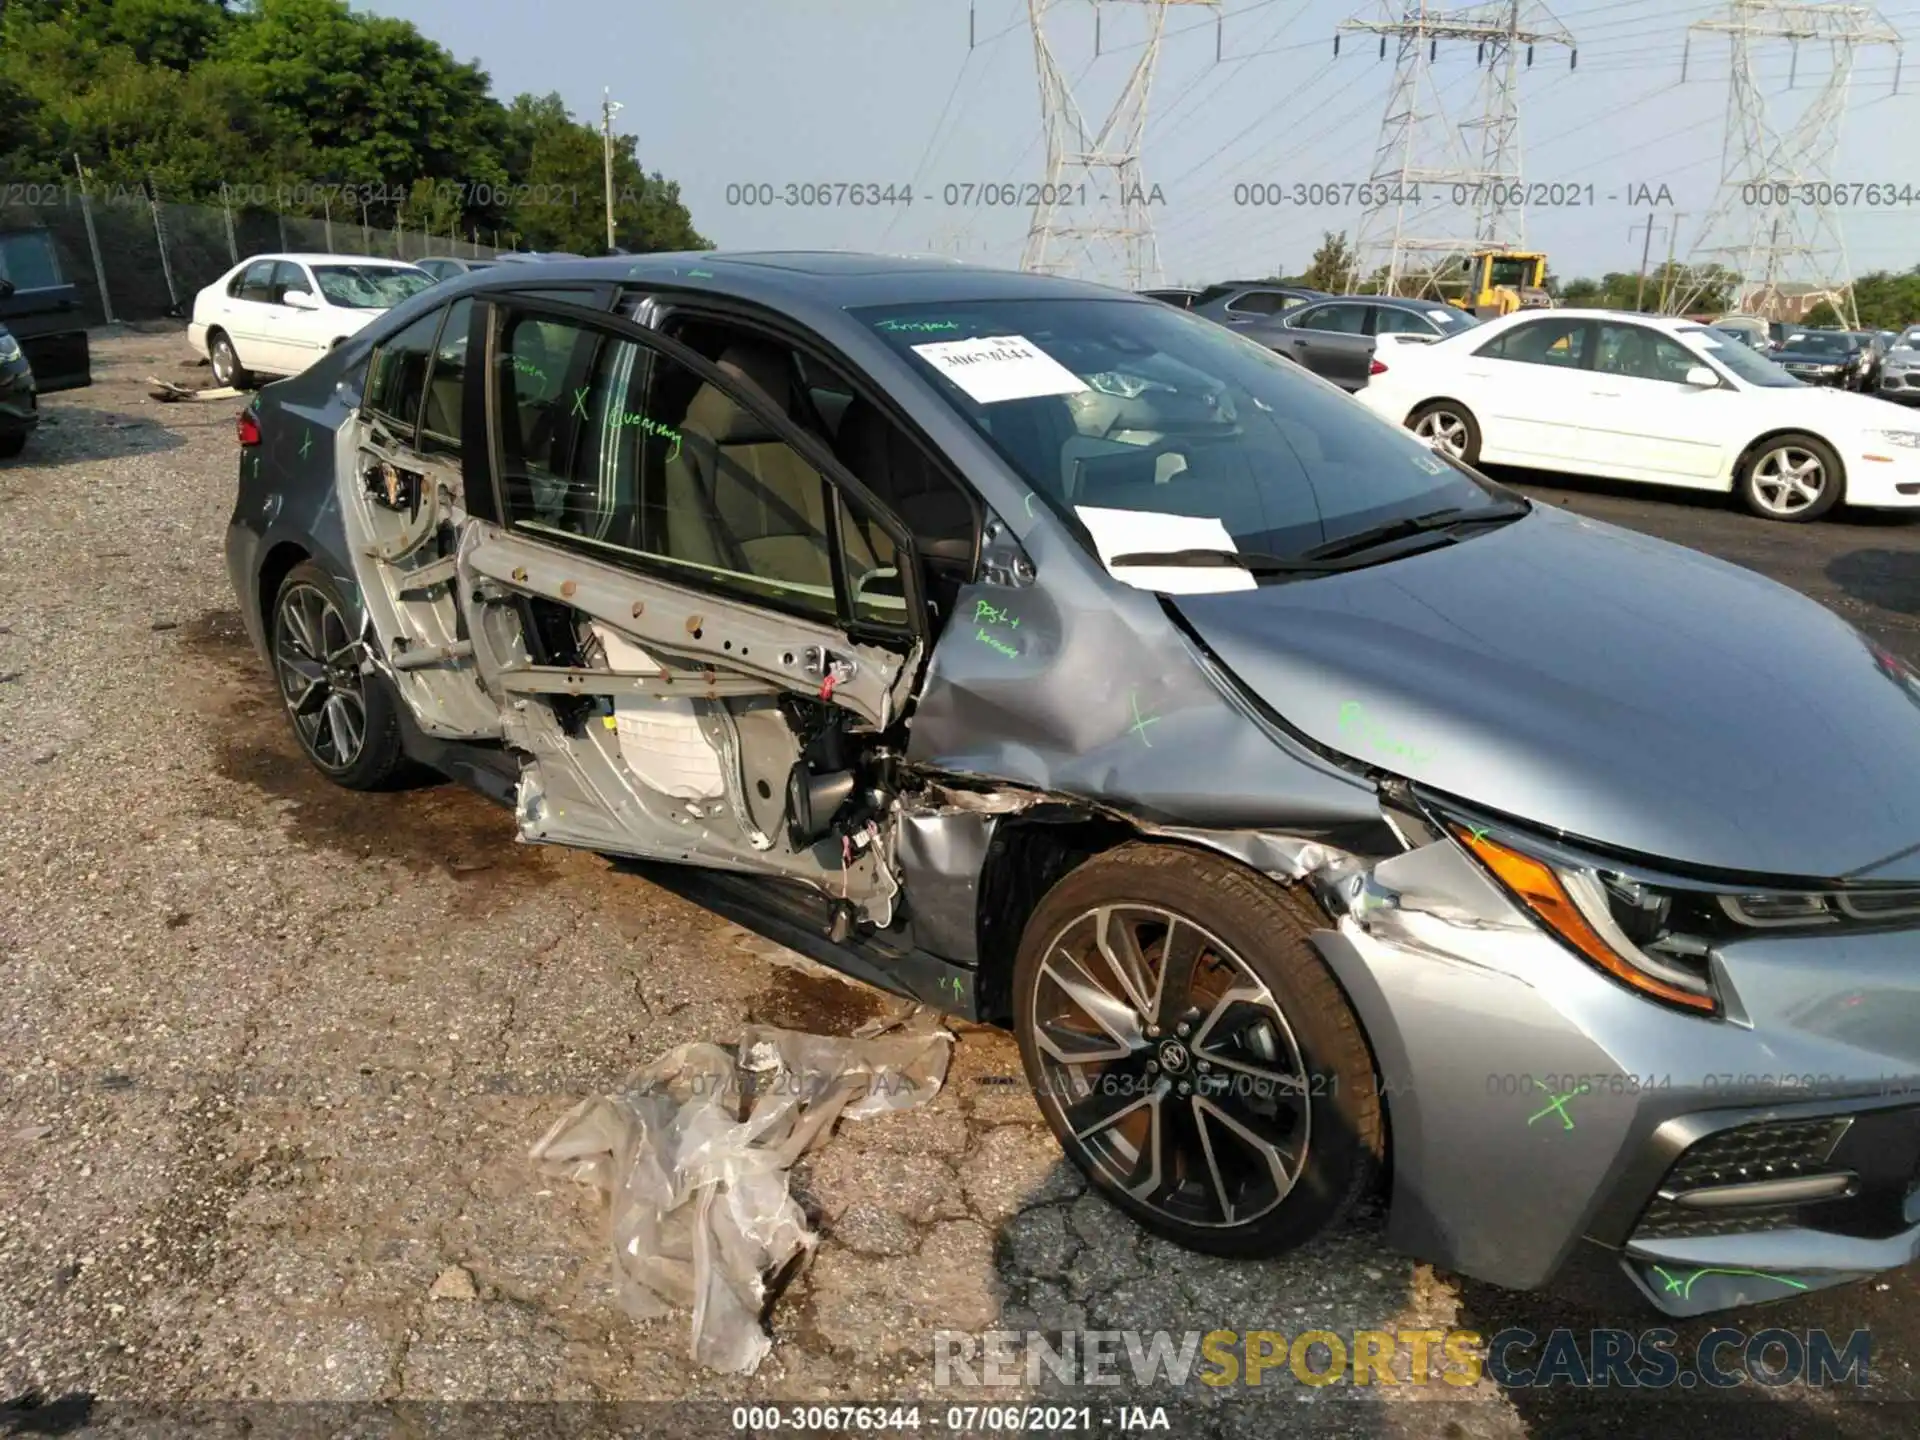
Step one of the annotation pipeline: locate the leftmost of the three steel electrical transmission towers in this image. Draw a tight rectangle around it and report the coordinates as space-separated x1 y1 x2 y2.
1020 0 1221 290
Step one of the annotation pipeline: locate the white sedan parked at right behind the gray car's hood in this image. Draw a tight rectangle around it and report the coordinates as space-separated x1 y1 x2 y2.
1357 309 1920 520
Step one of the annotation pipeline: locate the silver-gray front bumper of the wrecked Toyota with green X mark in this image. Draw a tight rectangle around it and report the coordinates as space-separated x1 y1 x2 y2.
1315 841 1920 1315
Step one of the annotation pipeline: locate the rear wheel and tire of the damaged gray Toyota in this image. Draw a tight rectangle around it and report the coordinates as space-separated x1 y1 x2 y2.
267 563 405 789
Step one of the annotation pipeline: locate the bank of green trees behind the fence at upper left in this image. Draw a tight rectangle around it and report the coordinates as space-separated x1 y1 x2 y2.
0 0 708 253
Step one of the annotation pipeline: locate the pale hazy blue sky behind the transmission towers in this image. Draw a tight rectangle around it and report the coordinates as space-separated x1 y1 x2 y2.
371 0 1920 282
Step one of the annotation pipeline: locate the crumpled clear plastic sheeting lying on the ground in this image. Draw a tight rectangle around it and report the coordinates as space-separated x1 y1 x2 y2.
532 1010 952 1373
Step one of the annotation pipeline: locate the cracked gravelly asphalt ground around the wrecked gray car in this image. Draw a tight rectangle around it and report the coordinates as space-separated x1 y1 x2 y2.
0 332 1920 1440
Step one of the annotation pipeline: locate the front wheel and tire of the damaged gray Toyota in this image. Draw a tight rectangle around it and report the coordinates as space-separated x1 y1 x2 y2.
1014 845 1386 1256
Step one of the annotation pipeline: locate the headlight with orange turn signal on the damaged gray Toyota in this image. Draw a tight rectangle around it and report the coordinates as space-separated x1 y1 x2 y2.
1453 822 1720 1016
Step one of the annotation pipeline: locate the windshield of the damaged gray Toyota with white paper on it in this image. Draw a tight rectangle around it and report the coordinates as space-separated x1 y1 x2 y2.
856 300 1513 559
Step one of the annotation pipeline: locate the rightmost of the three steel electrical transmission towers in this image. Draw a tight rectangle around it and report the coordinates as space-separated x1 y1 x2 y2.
1668 0 1901 328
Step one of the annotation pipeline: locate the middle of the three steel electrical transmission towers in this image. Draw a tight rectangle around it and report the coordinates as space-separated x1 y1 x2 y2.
1334 0 1580 296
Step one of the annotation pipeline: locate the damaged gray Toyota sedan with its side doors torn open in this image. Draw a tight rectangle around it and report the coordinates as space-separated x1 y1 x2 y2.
228 253 1920 1315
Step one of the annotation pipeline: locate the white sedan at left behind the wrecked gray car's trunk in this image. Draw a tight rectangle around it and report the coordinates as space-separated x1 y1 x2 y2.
186 255 434 386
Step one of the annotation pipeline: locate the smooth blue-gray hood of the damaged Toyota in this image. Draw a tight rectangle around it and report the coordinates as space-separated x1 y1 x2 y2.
1169 505 1920 881
